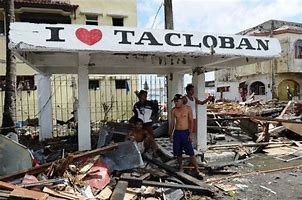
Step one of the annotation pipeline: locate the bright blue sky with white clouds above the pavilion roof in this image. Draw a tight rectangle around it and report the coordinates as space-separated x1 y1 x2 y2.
137 0 302 80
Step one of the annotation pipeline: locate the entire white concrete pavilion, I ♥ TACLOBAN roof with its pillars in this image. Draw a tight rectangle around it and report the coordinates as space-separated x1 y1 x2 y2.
10 22 281 151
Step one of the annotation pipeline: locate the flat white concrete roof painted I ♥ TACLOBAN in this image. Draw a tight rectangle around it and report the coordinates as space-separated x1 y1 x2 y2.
10 22 281 74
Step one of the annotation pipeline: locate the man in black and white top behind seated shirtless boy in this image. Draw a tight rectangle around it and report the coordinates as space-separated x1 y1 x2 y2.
133 90 159 138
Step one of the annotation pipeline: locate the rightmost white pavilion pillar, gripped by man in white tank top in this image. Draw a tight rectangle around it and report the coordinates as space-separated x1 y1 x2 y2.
192 69 208 152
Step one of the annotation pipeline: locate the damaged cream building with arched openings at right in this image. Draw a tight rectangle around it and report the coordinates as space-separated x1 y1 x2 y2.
215 20 302 101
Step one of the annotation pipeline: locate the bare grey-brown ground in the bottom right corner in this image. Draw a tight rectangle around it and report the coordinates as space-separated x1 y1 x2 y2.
204 155 302 200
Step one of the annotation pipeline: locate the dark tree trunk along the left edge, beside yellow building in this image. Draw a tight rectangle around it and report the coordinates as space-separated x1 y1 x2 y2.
1 0 16 134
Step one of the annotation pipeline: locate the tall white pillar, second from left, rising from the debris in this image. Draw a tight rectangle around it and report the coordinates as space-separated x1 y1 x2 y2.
78 53 91 151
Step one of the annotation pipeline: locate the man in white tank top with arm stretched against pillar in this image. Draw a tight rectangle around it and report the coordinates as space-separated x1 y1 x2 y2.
184 84 213 146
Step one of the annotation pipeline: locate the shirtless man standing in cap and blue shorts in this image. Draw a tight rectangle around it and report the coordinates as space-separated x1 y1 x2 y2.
169 94 204 178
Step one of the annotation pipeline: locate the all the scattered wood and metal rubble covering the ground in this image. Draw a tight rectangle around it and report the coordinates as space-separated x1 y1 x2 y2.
0 100 302 200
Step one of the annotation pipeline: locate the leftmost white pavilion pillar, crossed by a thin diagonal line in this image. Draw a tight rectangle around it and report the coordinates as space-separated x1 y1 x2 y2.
36 74 53 141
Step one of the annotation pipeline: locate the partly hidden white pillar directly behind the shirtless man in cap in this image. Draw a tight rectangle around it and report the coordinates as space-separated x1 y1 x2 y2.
168 73 184 120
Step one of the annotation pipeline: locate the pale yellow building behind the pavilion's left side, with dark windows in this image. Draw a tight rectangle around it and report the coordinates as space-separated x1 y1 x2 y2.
0 0 141 124
